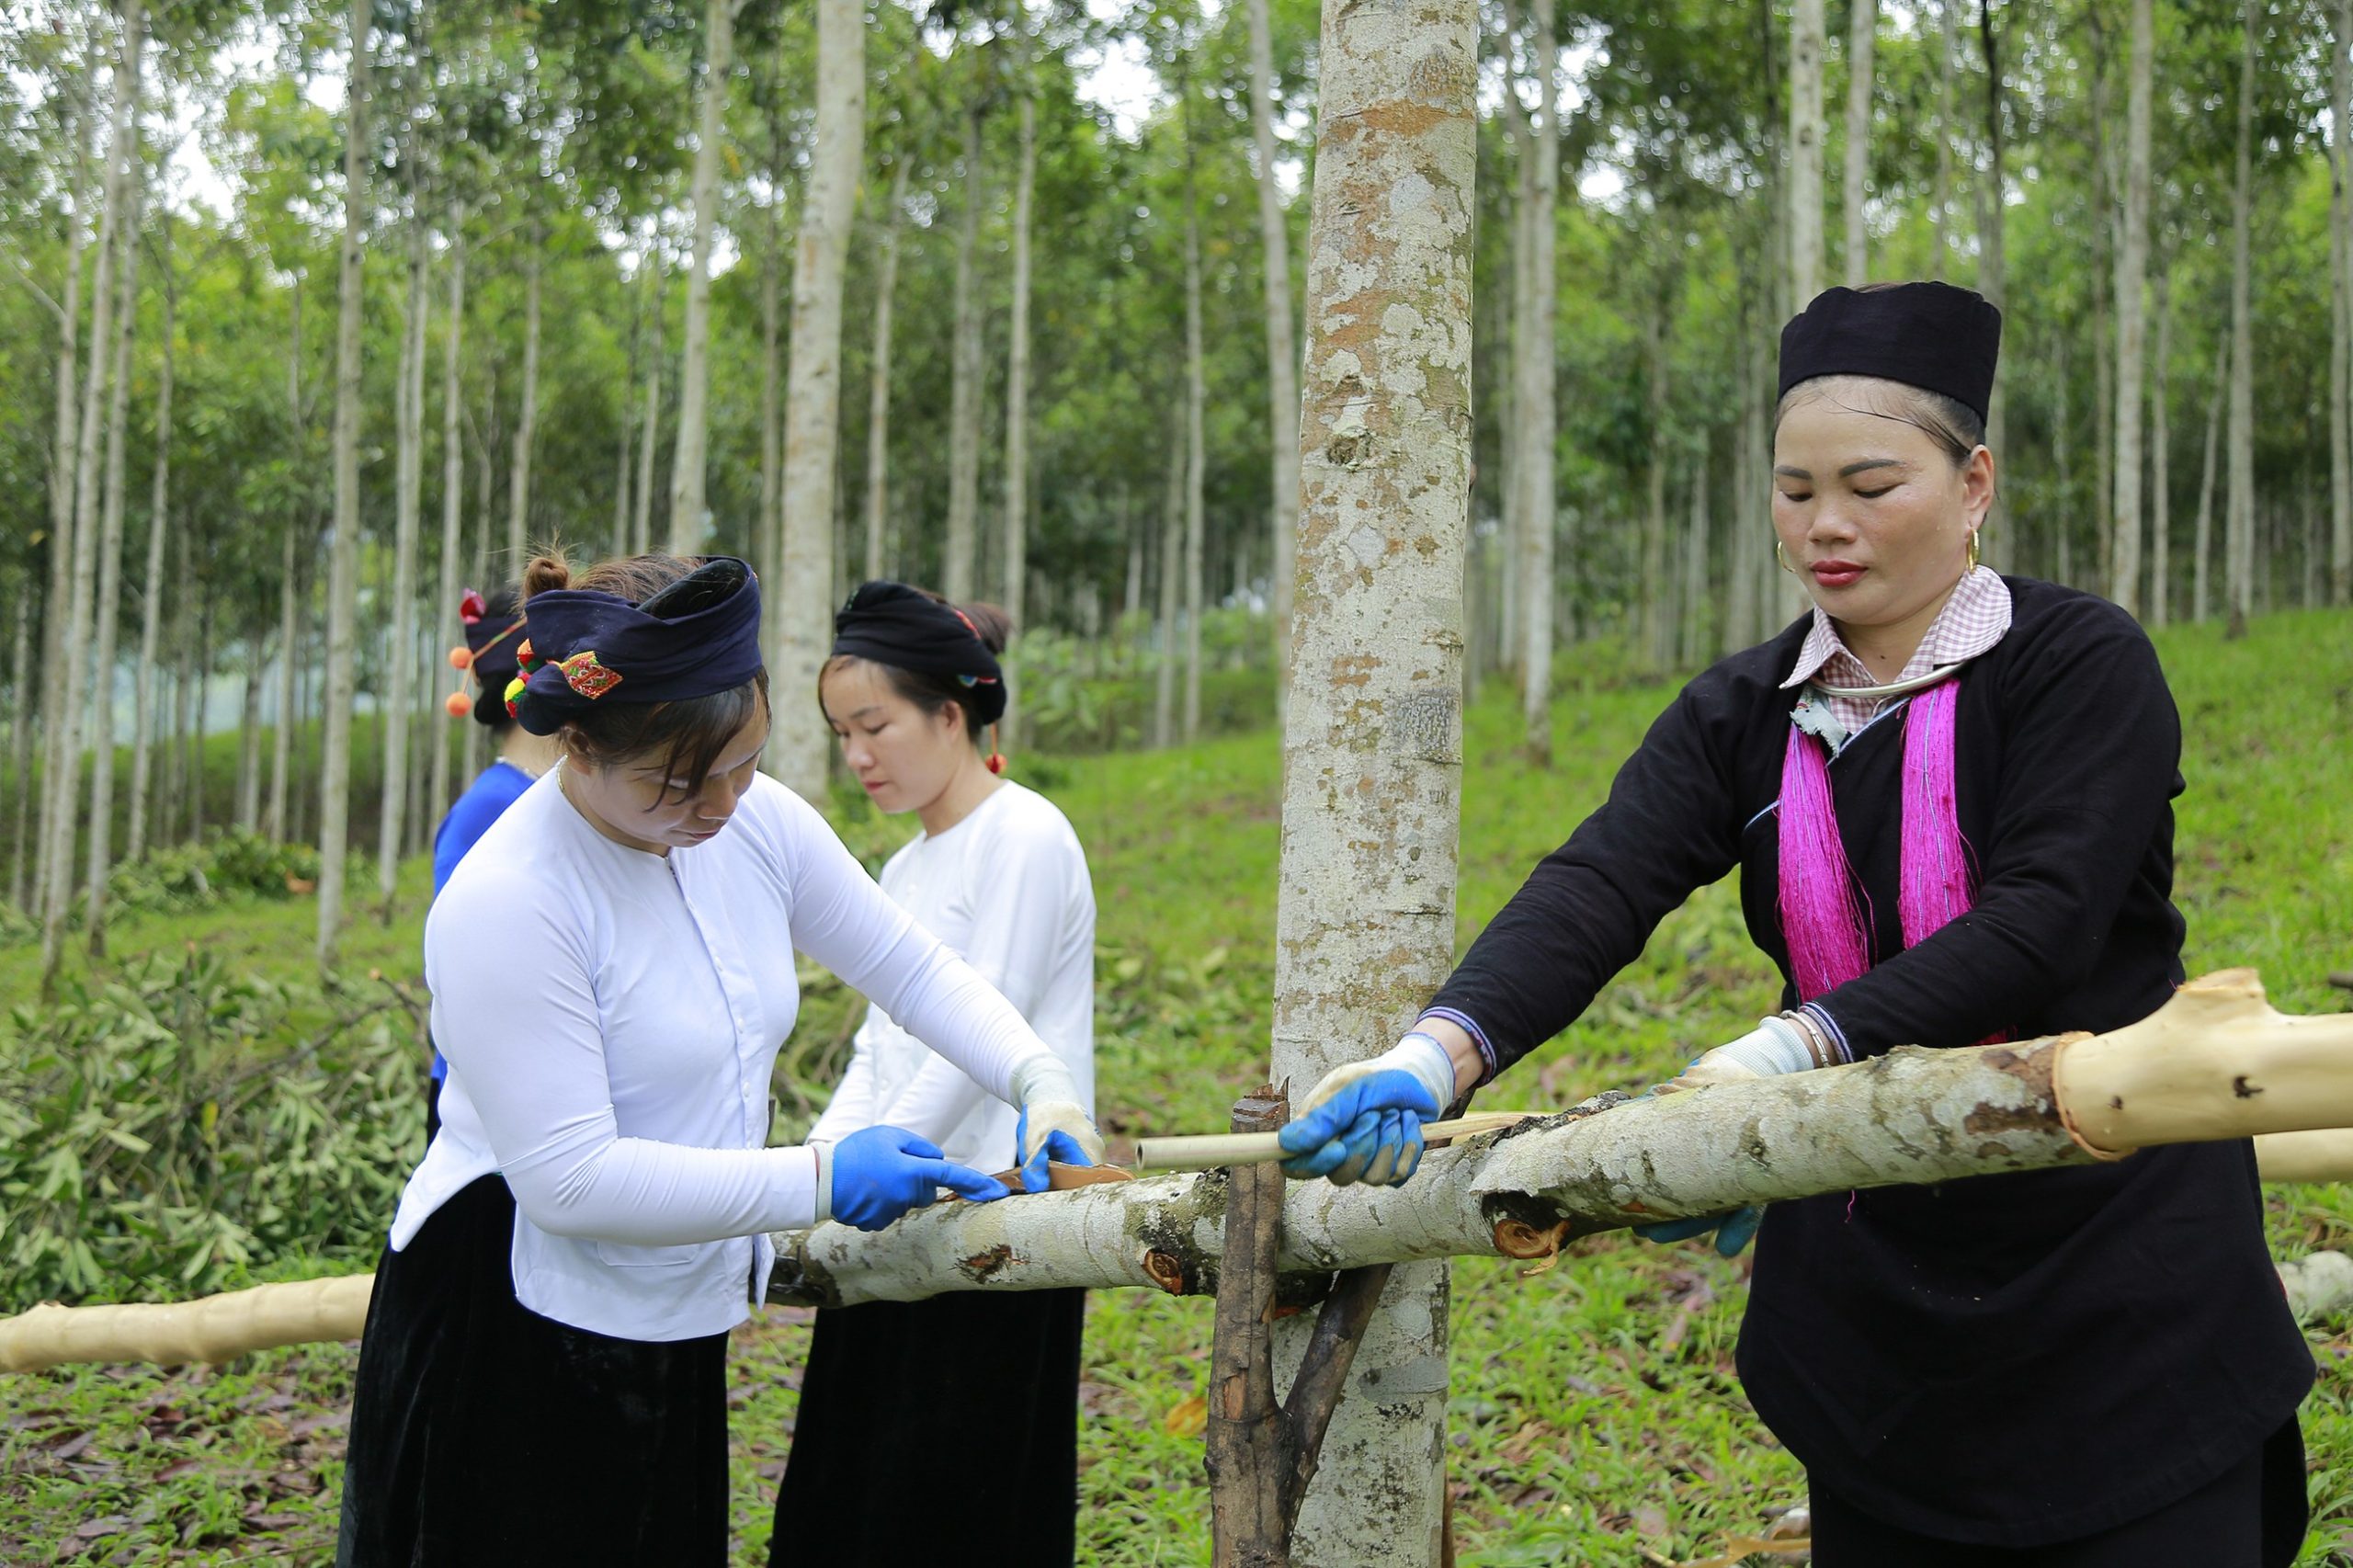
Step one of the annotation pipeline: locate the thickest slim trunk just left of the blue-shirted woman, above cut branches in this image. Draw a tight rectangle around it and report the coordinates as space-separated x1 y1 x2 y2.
318 0 371 968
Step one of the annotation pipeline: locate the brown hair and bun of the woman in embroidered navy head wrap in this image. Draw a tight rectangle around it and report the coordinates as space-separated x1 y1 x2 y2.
522 553 767 805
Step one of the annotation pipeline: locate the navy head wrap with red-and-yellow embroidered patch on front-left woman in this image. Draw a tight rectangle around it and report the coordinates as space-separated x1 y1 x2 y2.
506 556 762 734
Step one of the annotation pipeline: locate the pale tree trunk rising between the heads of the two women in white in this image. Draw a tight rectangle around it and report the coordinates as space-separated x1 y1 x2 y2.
769 0 866 801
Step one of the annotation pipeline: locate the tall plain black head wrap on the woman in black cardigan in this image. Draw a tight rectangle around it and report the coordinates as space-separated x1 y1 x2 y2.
1777 282 2003 419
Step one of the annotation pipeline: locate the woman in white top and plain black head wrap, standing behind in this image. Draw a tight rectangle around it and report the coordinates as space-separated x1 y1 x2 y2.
769 582 1094 1568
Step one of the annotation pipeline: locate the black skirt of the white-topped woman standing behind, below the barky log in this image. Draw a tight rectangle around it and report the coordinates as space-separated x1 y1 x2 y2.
767 1290 1087 1568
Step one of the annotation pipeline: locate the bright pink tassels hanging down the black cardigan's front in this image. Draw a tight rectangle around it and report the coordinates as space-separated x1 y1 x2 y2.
1779 678 1976 1003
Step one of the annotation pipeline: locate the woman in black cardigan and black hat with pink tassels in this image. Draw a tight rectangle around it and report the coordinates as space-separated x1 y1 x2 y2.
1285 282 2313 1568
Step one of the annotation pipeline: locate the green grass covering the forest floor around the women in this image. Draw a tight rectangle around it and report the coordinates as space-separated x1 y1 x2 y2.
0 600 2353 1568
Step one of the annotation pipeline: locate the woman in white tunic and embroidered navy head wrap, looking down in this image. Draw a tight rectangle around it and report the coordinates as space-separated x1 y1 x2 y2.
339 556 1101 1568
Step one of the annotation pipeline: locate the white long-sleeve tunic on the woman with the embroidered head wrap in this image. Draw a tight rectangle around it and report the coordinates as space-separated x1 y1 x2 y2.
391 770 1045 1340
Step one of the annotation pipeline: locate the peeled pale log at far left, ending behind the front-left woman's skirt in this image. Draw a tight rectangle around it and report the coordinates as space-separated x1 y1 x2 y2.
0 1274 377 1372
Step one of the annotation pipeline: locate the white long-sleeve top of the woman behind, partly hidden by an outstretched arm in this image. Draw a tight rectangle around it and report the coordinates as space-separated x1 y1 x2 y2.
810 781 1094 1170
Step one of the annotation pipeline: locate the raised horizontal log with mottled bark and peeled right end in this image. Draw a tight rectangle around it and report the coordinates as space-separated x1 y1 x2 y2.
769 970 2353 1304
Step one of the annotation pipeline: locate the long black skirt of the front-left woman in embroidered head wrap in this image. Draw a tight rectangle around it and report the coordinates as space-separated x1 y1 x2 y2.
336 1175 727 1568
